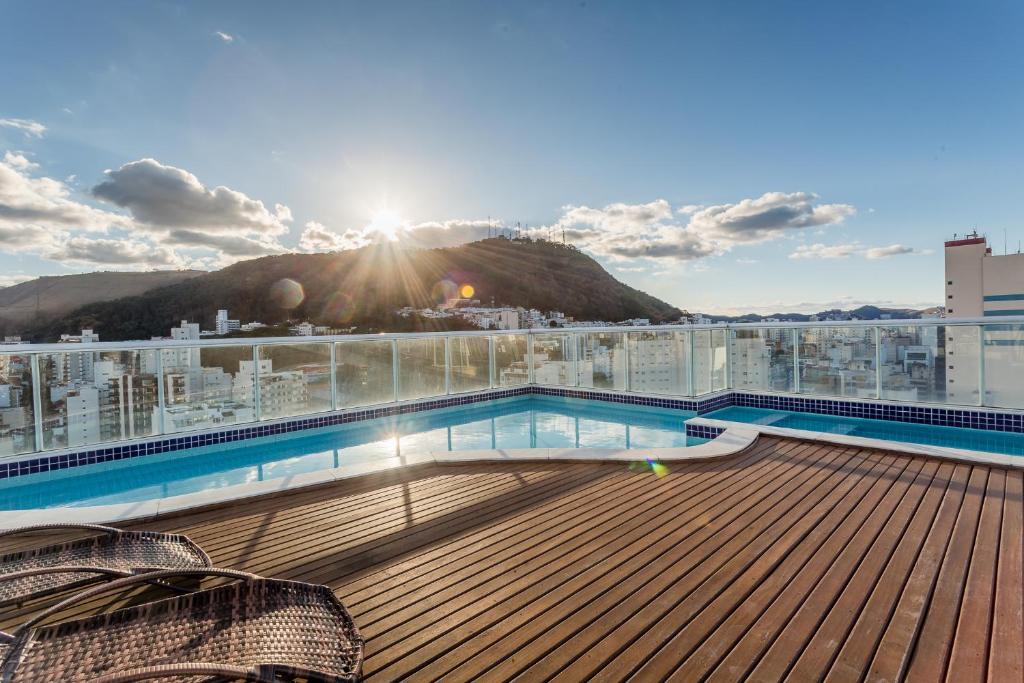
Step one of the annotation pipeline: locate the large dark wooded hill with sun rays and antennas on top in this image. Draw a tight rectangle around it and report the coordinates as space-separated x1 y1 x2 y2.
26 238 681 341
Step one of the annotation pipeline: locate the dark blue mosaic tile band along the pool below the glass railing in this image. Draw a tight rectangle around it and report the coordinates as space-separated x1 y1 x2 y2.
6 385 1024 479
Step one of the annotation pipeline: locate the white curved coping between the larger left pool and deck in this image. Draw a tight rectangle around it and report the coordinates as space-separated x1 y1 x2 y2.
0 423 759 530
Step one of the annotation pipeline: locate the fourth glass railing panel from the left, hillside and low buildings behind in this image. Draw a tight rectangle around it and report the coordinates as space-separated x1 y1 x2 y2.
256 344 331 420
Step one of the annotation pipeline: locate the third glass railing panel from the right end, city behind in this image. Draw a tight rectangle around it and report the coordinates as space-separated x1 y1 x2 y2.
800 326 877 398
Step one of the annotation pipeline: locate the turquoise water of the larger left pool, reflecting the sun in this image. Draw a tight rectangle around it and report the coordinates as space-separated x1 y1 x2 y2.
0 396 706 510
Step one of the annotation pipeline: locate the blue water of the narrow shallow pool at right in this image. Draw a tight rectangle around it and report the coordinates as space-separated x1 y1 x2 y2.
702 405 1024 456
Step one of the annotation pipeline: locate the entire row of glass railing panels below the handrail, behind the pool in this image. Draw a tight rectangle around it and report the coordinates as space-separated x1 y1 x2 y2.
0 318 1024 457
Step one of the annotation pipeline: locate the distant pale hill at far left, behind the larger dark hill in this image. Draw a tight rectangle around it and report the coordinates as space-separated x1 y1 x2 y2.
0 270 204 332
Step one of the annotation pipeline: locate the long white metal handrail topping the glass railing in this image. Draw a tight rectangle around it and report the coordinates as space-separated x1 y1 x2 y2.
0 315 1024 355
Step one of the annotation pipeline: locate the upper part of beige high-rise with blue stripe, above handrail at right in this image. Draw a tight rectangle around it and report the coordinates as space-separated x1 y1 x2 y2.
945 232 1024 317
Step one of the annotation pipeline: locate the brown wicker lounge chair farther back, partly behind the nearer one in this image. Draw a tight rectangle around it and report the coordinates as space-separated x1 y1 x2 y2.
0 524 212 607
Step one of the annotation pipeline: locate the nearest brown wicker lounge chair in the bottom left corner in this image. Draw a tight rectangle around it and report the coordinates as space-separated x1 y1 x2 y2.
0 569 362 683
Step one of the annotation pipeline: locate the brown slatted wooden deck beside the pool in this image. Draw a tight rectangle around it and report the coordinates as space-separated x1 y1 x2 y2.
0 438 1024 683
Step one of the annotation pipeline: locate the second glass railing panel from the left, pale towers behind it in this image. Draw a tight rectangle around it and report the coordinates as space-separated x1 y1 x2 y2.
39 349 159 449
